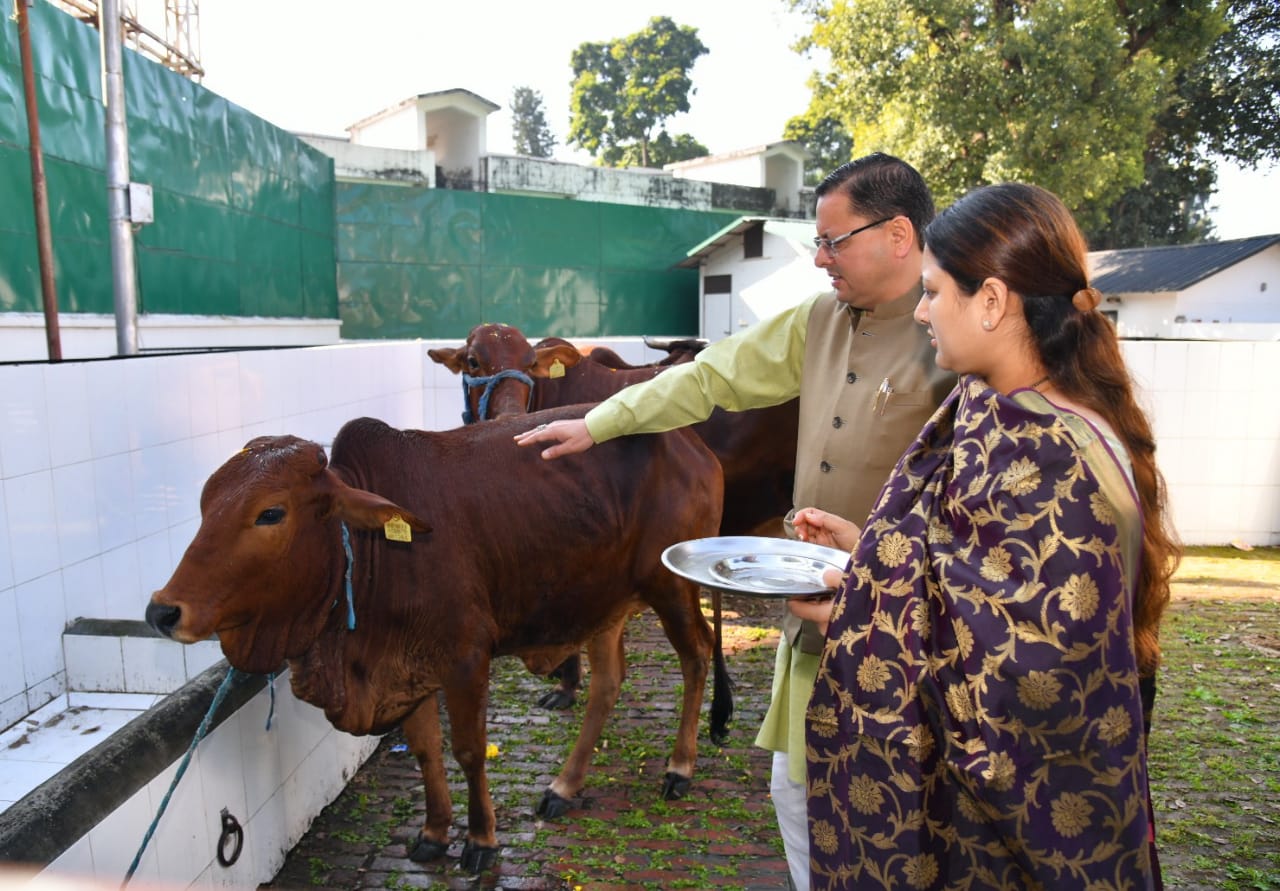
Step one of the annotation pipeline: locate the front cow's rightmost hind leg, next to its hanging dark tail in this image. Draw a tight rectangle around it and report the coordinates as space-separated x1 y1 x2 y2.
650 581 714 799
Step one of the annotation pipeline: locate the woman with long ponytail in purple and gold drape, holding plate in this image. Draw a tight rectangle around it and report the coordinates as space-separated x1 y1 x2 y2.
792 183 1176 891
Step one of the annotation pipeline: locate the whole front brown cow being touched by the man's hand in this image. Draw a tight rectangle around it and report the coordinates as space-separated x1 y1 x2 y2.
147 406 728 871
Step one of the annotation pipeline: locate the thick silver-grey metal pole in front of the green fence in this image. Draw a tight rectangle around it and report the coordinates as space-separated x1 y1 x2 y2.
99 0 138 356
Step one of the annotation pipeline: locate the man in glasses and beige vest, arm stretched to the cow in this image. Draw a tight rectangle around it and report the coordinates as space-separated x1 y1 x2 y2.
516 152 955 888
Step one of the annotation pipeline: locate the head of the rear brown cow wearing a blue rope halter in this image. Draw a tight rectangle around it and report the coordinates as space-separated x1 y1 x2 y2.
426 325 582 424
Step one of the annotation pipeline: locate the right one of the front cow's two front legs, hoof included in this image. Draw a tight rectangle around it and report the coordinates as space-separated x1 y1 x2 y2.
444 655 498 872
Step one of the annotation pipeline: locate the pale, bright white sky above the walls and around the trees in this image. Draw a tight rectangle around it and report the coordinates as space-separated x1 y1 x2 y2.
186 0 1280 239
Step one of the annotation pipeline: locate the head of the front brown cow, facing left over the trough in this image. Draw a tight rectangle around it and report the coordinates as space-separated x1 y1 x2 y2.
146 437 430 673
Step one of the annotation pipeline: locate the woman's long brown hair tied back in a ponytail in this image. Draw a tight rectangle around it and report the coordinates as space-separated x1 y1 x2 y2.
924 183 1180 675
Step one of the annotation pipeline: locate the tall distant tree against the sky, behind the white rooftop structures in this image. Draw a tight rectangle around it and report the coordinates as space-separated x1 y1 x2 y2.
568 15 708 166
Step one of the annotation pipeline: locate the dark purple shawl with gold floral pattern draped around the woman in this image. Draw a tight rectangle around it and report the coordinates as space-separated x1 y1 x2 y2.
806 378 1156 891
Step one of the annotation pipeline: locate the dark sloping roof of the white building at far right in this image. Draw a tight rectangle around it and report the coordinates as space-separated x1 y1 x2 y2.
1089 233 1280 294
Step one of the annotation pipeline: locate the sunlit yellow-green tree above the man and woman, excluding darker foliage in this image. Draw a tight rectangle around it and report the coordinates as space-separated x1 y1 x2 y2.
799 0 1233 230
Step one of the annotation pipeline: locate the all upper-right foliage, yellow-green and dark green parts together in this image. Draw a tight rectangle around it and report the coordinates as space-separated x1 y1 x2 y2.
796 0 1277 243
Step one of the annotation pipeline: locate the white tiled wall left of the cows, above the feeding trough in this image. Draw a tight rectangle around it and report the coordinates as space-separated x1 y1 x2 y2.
0 342 461 728
